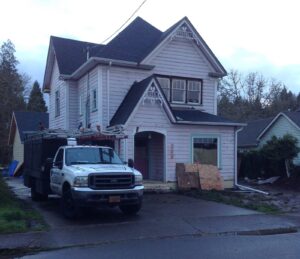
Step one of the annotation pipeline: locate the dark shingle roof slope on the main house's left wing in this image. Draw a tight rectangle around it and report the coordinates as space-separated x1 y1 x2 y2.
51 36 104 75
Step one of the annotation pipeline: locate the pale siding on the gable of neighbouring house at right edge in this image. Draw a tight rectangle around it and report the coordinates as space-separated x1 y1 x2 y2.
259 115 300 165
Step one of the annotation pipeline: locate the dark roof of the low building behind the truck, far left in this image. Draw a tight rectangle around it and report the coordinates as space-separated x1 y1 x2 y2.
14 112 49 142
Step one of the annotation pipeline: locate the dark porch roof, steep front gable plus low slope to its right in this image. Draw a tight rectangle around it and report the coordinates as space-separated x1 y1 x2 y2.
110 75 244 126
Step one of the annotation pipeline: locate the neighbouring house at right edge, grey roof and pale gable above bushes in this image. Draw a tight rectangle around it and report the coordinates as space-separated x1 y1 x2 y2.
238 111 300 165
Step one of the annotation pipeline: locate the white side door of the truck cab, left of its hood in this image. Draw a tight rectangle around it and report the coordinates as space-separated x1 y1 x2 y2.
50 148 64 192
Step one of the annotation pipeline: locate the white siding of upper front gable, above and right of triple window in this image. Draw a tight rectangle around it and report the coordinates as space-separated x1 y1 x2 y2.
147 39 216 114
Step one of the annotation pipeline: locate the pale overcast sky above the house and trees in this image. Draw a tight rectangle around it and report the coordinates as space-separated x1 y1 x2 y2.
0 0 300 93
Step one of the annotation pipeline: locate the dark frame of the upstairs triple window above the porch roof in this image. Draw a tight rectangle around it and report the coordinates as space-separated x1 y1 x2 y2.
154 74 203 106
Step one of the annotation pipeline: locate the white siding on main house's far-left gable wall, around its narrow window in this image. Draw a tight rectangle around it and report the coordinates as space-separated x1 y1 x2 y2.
49 60 67 129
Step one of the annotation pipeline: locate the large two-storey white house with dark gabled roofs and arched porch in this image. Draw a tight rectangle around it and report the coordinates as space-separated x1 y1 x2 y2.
43 17 243 187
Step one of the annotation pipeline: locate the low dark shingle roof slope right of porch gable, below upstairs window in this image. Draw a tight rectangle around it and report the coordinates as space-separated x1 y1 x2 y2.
172 108 236 124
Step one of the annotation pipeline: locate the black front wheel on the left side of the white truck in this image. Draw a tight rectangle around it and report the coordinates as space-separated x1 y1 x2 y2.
61 189 80 219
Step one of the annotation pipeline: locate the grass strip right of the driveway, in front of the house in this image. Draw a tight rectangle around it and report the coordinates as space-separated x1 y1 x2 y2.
183 190 282 214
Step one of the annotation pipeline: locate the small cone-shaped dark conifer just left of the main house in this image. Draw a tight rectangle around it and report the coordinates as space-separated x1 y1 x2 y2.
27 81 47 112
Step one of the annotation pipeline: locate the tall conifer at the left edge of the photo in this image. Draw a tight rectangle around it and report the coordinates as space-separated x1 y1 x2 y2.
0 40 26 163
